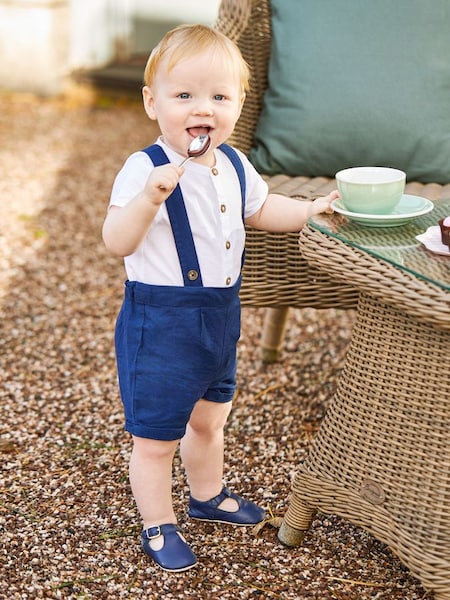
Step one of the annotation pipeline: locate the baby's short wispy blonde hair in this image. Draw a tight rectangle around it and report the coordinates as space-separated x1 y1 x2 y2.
144 25 250 92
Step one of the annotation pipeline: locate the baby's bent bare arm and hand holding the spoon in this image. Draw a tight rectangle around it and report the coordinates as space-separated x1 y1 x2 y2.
102 164 184 256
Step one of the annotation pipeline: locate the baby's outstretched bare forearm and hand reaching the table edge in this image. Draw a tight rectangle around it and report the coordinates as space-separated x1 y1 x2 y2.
245 191 339 232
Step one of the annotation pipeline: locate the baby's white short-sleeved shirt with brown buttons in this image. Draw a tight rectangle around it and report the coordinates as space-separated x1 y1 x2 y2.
110 139 268 287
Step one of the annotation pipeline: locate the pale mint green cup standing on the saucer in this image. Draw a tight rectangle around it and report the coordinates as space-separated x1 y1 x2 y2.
336 167 406 215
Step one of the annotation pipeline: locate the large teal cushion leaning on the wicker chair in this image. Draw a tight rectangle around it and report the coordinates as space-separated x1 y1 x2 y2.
250 0 450 183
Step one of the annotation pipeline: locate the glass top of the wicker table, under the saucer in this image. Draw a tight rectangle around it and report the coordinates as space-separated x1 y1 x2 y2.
308 199 450 291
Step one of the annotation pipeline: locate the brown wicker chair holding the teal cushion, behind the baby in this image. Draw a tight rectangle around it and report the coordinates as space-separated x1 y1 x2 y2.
216 0 450 362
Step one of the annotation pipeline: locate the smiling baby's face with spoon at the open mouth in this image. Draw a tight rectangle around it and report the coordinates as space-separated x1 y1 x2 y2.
144 53 244 165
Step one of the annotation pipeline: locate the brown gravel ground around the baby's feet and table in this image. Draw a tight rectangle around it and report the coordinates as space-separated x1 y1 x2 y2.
0 94 431 600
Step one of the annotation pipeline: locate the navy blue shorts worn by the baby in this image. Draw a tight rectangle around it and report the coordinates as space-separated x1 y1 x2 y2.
115 281 240 440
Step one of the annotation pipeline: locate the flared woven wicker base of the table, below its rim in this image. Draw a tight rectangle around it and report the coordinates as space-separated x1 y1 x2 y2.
285 294 450 600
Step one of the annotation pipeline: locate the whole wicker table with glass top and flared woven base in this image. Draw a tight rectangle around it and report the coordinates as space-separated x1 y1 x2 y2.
279 200 450 600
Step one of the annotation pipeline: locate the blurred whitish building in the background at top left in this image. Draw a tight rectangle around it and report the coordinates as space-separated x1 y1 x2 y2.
0 0 220 95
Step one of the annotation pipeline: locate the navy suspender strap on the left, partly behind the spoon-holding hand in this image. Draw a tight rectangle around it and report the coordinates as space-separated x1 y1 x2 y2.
143 144 203 287
